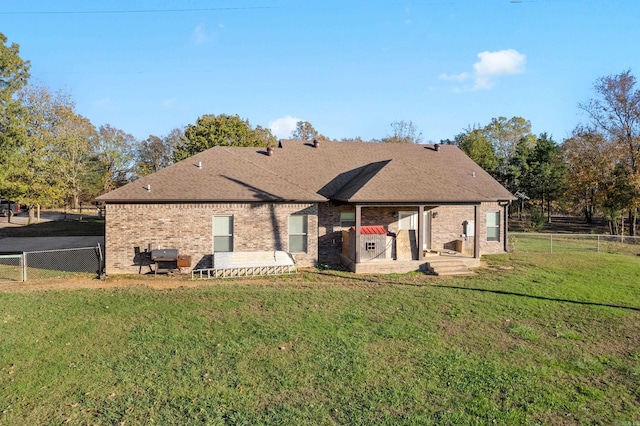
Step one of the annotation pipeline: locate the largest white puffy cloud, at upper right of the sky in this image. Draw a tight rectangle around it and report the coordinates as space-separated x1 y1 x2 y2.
439 49 527 90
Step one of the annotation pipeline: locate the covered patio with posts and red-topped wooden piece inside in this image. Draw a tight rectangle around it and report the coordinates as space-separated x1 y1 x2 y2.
340 203 506 274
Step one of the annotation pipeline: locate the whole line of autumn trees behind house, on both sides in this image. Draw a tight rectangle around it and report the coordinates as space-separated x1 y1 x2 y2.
0 33 640 235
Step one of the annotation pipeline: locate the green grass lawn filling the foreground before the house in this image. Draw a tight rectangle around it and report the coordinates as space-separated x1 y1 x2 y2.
0 253 640 425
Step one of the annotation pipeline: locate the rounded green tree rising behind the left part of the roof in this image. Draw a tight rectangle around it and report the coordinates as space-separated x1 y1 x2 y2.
174 114 276 161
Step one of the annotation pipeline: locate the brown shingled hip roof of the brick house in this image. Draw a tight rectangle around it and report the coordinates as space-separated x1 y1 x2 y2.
97 140 514 203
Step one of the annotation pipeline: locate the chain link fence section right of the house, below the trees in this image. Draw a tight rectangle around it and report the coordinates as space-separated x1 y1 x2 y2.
509 232 640 256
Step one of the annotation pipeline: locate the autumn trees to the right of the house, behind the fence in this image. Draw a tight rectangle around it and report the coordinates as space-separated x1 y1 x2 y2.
450 70 640 235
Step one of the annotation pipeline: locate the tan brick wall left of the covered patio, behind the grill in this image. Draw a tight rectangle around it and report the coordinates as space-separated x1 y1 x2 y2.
105 203 318 274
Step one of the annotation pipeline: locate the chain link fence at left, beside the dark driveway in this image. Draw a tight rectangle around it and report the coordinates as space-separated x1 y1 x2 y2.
0 245 104 281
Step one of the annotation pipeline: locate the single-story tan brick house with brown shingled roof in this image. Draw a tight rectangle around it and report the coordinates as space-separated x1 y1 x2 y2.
97 140 513 274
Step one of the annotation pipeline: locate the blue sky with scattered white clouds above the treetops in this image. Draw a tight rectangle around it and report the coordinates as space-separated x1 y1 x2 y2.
0 0 640 142
